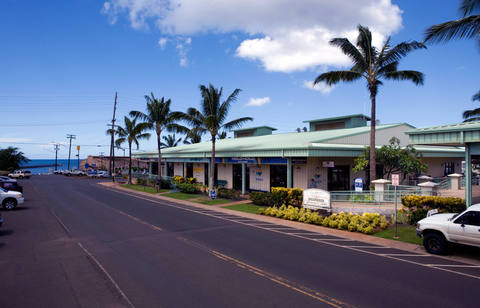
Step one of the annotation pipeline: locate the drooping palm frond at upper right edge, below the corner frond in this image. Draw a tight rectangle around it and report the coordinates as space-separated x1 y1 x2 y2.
425 15 480 43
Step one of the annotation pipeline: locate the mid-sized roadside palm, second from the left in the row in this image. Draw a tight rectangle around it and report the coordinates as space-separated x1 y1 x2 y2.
130 92 187 179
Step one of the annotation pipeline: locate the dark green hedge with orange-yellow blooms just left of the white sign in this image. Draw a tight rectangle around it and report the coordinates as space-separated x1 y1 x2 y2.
250 187 303 207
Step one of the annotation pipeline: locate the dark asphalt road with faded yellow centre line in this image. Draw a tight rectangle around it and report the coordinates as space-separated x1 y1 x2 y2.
0 176 480 307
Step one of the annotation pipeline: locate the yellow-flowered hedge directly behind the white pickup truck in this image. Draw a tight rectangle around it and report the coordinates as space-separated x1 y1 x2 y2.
402 195 466 224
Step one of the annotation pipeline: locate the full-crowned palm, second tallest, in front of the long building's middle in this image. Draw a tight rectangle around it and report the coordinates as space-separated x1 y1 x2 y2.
185 84 253 190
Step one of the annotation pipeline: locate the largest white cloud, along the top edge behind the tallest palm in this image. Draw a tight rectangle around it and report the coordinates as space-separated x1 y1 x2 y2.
103 0 402 72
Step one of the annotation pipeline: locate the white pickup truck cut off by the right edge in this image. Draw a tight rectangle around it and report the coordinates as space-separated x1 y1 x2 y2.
417 204 480 254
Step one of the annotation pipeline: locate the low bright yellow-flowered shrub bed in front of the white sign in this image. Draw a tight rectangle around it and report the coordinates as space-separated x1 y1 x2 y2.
259 205 388 234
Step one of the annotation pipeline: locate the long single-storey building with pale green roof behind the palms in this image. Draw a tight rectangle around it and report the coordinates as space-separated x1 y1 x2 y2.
135 115 464 193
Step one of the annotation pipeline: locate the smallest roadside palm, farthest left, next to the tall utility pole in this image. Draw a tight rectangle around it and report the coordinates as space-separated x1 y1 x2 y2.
115 117 150 184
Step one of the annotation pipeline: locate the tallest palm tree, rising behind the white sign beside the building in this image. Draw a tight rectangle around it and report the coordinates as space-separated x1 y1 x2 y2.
314 25 425 183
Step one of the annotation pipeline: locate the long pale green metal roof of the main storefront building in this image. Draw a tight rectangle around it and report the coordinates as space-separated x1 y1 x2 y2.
134 123 463 158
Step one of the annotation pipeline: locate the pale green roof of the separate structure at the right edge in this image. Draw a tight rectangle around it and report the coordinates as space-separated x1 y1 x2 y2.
406 121 480 146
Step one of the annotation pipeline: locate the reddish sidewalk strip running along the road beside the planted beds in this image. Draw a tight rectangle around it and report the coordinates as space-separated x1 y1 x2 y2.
99 182 480 265
